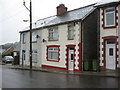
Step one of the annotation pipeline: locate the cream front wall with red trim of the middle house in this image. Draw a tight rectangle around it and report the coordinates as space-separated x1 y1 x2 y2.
42 23 80 71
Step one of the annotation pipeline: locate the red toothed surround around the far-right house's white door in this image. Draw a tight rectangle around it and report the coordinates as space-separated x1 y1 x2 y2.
102 36 118 70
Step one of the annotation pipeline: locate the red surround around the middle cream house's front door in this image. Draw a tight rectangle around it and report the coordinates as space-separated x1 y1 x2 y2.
66 45 76 71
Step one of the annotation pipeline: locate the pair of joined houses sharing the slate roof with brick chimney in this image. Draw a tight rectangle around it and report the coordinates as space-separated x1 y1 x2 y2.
20 4 99 71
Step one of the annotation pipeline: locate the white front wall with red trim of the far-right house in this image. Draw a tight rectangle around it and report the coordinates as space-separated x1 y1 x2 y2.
100 5 120 70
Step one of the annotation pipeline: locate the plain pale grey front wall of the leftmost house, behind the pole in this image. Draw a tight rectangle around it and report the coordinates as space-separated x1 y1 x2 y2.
20 30 42 67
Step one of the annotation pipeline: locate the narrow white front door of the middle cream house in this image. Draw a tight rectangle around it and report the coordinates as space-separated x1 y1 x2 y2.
68 47 74 71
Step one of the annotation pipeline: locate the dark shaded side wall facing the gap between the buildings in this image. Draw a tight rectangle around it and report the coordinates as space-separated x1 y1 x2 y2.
82 10 97 60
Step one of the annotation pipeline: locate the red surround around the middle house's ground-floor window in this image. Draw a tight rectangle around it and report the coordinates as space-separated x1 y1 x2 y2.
46 45 60 62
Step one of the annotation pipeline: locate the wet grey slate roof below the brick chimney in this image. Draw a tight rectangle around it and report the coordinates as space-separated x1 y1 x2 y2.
20 4 95 33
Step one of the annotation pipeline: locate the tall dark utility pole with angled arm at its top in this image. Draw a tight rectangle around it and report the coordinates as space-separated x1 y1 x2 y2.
23 0 32 70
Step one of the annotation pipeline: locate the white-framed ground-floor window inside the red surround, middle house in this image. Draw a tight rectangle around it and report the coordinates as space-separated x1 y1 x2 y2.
48 47 59 61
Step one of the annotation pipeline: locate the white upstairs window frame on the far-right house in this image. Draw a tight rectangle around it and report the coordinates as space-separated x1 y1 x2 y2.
104 7 115 27
